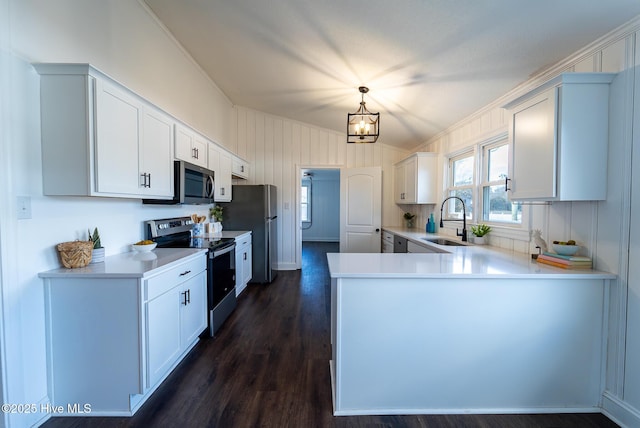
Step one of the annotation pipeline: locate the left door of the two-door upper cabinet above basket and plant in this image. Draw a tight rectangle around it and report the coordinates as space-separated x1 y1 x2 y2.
95 79 143 195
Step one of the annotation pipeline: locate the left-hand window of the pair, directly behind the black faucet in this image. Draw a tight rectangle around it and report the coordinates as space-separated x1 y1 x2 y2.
446 153 475 220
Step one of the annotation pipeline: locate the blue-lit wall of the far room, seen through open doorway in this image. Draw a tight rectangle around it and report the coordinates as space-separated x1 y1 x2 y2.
302 170 340 242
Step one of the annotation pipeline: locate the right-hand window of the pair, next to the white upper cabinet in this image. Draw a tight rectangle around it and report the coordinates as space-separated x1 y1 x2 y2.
481 141 522 224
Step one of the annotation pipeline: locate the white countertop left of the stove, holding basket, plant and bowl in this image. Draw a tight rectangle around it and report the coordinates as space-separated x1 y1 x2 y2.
38 248 207 278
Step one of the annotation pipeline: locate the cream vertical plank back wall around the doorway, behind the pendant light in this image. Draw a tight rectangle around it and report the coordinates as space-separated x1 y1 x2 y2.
227 106 409 269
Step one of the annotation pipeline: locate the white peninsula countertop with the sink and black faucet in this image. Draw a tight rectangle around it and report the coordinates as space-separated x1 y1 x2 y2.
327 227 616 279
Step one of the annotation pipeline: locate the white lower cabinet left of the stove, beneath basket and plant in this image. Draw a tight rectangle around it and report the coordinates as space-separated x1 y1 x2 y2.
40 249 207 416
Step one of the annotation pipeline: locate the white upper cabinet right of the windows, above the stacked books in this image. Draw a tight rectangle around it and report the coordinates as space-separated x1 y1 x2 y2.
505 73 615 201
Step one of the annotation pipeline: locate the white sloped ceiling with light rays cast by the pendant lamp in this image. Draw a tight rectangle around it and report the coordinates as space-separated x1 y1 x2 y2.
145 0 640 149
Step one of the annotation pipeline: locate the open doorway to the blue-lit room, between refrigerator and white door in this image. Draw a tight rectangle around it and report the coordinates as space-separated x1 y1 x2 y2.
296 166 340 269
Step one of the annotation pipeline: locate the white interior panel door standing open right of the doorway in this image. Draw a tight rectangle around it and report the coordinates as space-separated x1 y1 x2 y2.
340 167 382 253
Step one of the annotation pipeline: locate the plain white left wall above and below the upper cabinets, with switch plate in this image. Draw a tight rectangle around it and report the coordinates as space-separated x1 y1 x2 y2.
0 0 232 426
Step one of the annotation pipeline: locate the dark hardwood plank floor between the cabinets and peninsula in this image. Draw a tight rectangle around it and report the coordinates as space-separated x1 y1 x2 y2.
44 243 617 428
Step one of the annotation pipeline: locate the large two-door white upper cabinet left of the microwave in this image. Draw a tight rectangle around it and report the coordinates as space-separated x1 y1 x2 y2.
35 64 173 199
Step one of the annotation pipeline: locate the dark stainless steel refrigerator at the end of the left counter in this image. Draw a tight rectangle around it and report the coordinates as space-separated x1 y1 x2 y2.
220 184 278 284
